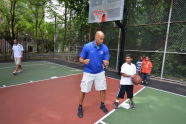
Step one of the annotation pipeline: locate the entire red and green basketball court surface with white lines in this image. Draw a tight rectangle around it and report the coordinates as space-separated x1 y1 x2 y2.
0 61 186 124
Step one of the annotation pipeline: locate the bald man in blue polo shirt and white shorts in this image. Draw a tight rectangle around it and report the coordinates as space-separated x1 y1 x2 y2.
77 31 109 118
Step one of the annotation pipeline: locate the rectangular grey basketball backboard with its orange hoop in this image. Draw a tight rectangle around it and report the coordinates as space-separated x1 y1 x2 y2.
88 0 124 23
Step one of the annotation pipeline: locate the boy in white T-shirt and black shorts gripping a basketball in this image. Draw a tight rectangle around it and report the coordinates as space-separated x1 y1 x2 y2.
114 54 136 109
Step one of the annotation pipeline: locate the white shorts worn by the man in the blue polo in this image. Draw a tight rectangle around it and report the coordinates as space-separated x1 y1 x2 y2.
80 71 107 93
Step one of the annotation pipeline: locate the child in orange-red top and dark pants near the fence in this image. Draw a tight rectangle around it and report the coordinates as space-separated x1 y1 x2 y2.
141 56 153 84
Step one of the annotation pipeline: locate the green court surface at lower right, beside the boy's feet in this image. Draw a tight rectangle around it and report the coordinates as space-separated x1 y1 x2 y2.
97 88 186 124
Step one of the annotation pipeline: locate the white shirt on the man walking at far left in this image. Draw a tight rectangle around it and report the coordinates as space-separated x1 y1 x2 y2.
12 43 24 58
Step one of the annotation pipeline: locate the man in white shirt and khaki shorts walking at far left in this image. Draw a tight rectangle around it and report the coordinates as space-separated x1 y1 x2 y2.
12 39 24 75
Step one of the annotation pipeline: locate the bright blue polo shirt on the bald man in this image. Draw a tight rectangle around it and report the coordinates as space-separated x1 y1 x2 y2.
80 41 109 74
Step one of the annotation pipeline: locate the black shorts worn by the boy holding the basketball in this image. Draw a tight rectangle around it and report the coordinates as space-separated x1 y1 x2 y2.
117 85 134 99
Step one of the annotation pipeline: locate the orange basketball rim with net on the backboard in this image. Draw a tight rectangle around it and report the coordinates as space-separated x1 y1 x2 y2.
93 10 106 22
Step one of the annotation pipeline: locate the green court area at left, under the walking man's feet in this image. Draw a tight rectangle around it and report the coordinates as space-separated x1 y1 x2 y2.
0 61 82 87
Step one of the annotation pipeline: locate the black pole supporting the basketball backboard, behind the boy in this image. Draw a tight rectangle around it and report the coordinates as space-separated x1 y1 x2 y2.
115 0 127 75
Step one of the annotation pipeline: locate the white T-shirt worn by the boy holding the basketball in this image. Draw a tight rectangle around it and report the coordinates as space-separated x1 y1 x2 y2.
120 63 136 85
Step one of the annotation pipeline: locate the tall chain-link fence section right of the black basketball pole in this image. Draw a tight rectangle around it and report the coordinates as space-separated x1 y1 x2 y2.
125 0 186 82
